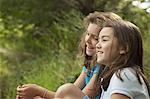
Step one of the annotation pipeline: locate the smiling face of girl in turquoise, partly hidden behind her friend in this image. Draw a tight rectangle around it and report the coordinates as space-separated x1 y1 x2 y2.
85 23 100 56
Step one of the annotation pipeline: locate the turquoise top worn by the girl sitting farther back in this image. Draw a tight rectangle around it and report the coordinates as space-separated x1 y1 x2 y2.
82 64 100 99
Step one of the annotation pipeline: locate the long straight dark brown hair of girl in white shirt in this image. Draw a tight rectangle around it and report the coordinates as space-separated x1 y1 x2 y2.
95 20 150 94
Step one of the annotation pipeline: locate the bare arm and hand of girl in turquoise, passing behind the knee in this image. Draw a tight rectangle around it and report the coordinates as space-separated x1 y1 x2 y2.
16 67 86 99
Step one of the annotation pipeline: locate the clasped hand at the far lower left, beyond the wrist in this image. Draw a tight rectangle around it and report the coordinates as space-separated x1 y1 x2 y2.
16 84 44 99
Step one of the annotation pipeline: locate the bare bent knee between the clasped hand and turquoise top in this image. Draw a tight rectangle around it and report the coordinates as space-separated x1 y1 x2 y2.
55 83 74 98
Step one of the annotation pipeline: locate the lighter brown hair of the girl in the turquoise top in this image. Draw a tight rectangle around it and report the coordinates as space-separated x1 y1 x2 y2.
78 11 122 68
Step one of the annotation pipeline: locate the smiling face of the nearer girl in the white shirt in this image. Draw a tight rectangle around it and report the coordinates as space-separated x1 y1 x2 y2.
96 27 120 65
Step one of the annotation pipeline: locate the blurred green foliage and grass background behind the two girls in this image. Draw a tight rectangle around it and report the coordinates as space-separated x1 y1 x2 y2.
0 0 150 99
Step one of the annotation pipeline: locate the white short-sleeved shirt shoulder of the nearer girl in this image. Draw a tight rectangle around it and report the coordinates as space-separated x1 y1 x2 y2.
108 68 148 99
